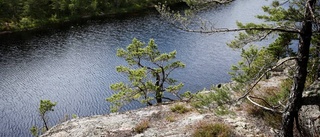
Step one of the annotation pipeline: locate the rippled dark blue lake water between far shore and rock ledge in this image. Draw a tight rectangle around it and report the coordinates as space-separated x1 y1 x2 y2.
0 0 270 137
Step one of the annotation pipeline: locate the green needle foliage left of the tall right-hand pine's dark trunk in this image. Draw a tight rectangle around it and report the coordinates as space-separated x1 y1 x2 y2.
228 1 300 85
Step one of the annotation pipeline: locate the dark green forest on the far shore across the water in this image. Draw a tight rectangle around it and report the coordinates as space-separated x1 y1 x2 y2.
0 0 181 33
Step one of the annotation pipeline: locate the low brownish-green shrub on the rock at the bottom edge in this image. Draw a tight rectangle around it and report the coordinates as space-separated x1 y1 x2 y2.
192 122 234 137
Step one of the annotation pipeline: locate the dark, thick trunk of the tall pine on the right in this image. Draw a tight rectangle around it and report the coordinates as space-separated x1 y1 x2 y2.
282 0 316 137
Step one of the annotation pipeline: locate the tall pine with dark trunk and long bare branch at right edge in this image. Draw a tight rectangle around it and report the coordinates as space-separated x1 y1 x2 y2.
158 0 320 137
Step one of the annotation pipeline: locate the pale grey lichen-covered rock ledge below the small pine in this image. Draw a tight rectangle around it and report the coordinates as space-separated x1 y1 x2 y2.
42 103 273 137
